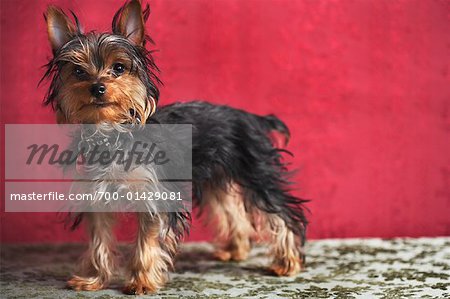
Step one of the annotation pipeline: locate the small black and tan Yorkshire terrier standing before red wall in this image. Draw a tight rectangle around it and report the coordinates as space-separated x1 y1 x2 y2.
43 0 307 294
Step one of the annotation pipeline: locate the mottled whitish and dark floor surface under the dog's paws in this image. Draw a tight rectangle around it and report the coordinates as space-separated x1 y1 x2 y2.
0 238 450 299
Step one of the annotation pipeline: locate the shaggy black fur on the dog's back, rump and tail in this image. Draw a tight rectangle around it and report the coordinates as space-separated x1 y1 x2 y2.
148 102 307 258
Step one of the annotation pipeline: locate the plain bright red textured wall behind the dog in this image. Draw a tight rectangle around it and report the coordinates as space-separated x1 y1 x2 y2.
1 0 450 242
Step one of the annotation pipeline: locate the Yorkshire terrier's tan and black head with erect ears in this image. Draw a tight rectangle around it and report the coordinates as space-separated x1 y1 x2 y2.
43 0 160 124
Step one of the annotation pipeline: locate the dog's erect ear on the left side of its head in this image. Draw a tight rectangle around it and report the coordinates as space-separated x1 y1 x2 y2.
44 6 79 53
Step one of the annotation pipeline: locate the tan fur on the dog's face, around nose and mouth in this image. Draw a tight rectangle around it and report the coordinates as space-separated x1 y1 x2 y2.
54 44 151 123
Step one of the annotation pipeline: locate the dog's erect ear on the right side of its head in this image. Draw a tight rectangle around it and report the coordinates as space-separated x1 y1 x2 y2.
112 0 149 46
